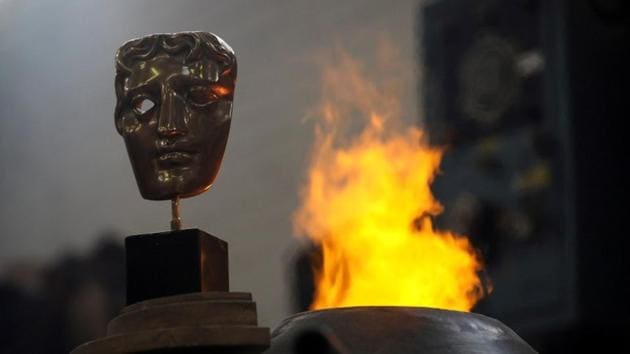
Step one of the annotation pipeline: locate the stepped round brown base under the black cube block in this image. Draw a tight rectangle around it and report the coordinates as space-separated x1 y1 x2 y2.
71 292 270 354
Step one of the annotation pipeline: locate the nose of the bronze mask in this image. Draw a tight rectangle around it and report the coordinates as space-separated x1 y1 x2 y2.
158 89 188 138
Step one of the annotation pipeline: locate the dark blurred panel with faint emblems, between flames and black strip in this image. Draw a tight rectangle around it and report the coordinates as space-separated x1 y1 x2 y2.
418 0 575 333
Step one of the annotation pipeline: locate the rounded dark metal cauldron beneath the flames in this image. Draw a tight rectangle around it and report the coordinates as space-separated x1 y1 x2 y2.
265 307 536 354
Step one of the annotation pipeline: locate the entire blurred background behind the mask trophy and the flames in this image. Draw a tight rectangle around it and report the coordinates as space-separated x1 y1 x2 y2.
0 0 630 353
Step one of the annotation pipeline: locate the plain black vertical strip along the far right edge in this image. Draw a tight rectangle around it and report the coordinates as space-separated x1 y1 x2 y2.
566 1 630 326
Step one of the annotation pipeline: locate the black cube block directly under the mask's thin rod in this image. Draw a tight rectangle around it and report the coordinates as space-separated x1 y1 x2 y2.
125 229 229 305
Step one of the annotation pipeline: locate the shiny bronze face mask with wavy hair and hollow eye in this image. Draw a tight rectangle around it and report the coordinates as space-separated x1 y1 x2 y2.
114 32 236 200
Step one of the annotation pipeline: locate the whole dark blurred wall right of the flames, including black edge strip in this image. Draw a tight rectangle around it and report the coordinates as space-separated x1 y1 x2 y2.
419 0 630 353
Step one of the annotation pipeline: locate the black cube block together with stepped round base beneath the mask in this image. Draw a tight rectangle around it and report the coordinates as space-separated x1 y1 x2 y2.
71 229 270 354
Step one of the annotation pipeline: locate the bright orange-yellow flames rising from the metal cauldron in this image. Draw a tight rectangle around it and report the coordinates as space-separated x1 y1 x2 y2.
294 42 484 311
